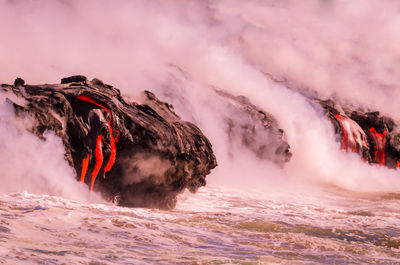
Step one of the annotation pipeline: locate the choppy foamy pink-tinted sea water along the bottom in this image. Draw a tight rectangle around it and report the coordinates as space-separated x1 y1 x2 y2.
0 188 400 264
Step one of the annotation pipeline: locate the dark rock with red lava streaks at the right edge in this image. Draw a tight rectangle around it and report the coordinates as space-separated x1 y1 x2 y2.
316 99 400 168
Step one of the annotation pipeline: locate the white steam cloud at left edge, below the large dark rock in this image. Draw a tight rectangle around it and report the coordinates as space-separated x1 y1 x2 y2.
0 95 98 200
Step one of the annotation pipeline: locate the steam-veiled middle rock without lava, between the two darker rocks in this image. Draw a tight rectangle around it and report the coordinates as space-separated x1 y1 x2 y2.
152 65 292 166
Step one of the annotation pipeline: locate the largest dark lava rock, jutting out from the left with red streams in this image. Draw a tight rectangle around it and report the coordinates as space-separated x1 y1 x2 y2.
1 76 217 209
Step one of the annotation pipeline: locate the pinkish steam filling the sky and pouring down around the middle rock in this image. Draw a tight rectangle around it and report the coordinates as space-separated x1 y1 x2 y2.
0 0 400 198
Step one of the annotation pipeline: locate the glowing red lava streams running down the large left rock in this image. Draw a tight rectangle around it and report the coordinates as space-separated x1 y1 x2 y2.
77 95 118 190
